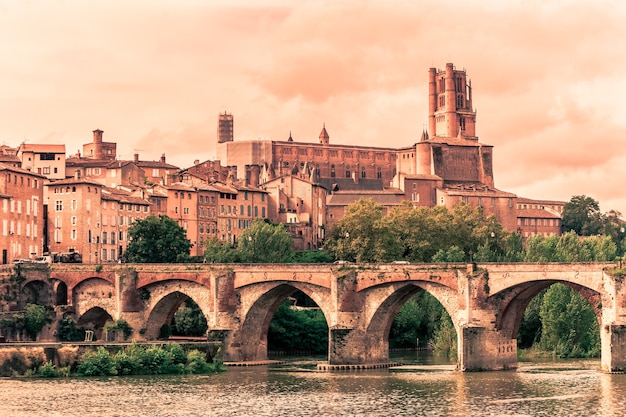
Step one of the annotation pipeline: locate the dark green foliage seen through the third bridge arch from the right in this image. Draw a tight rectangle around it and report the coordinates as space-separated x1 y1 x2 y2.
267 300 328 353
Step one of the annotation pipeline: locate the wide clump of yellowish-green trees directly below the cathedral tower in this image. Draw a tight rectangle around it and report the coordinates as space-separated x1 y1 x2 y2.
325 198 522 262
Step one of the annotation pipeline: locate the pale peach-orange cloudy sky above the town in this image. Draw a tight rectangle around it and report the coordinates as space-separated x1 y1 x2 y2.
0 0 626 216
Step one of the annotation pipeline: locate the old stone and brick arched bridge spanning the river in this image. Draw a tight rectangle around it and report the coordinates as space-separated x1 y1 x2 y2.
12 263 626 371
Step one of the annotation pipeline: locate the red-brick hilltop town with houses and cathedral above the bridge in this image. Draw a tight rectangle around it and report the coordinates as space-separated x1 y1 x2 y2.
0 63 565 264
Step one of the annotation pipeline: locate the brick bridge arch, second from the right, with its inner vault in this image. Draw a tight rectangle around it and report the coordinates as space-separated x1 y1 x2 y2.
364 281 459 363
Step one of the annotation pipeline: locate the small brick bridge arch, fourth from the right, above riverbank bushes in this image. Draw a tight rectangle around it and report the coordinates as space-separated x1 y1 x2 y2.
140 279 212 340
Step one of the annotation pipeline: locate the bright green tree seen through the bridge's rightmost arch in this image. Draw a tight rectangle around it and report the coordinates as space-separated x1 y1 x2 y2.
540 284 600 357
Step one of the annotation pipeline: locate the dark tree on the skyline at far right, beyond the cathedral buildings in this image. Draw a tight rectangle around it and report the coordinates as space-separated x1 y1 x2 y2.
561 195 603 236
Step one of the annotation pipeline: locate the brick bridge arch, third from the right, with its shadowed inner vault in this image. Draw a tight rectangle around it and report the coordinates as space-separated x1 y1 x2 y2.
225 282 331 361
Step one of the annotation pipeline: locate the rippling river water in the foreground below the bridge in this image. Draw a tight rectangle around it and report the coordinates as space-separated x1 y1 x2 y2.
0 352 626 417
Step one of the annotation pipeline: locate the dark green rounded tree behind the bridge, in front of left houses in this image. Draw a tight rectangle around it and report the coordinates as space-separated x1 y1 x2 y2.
124 214 193 263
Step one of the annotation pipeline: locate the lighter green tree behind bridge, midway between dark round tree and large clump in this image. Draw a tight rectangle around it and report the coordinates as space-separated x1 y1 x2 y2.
237 218 293 263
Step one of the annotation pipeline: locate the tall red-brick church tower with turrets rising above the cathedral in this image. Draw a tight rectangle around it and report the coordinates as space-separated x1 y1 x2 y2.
428 63 478 140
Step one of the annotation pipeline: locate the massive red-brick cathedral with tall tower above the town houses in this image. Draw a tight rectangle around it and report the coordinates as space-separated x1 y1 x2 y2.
217 63 565 242
